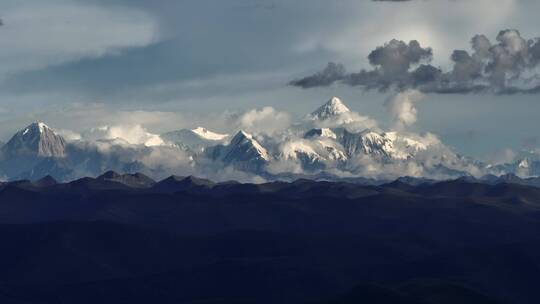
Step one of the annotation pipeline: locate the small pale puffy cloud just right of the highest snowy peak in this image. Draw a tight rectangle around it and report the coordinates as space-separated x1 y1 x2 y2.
385 90 424 129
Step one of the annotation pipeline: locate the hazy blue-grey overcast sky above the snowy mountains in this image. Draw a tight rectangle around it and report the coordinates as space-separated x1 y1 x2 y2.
0 0 540 157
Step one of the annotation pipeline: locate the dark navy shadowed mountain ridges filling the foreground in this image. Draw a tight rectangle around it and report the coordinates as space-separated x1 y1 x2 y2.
0 171 540 304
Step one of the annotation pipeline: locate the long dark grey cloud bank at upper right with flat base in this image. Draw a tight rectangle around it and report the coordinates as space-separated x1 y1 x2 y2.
290 30 540 94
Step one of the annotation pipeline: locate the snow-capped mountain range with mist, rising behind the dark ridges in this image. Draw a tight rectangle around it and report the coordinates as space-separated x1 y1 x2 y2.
0 97 540 181
